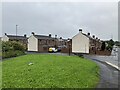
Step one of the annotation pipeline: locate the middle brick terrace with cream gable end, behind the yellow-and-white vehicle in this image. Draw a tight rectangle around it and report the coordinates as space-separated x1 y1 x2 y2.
28 32 71 52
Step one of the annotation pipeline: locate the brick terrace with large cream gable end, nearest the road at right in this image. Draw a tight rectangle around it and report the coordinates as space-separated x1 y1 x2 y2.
72 29 102 54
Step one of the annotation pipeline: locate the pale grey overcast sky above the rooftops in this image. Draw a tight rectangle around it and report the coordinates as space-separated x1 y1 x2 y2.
2 2 118 40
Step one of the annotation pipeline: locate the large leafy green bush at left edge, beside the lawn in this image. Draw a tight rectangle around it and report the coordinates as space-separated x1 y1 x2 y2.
2 41 25 58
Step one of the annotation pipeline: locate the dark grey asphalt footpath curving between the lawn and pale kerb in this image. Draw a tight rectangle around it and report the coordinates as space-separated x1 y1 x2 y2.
86 56 120 88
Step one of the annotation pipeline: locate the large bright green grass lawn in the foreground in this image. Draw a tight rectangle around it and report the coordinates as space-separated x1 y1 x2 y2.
2 54 99 88
